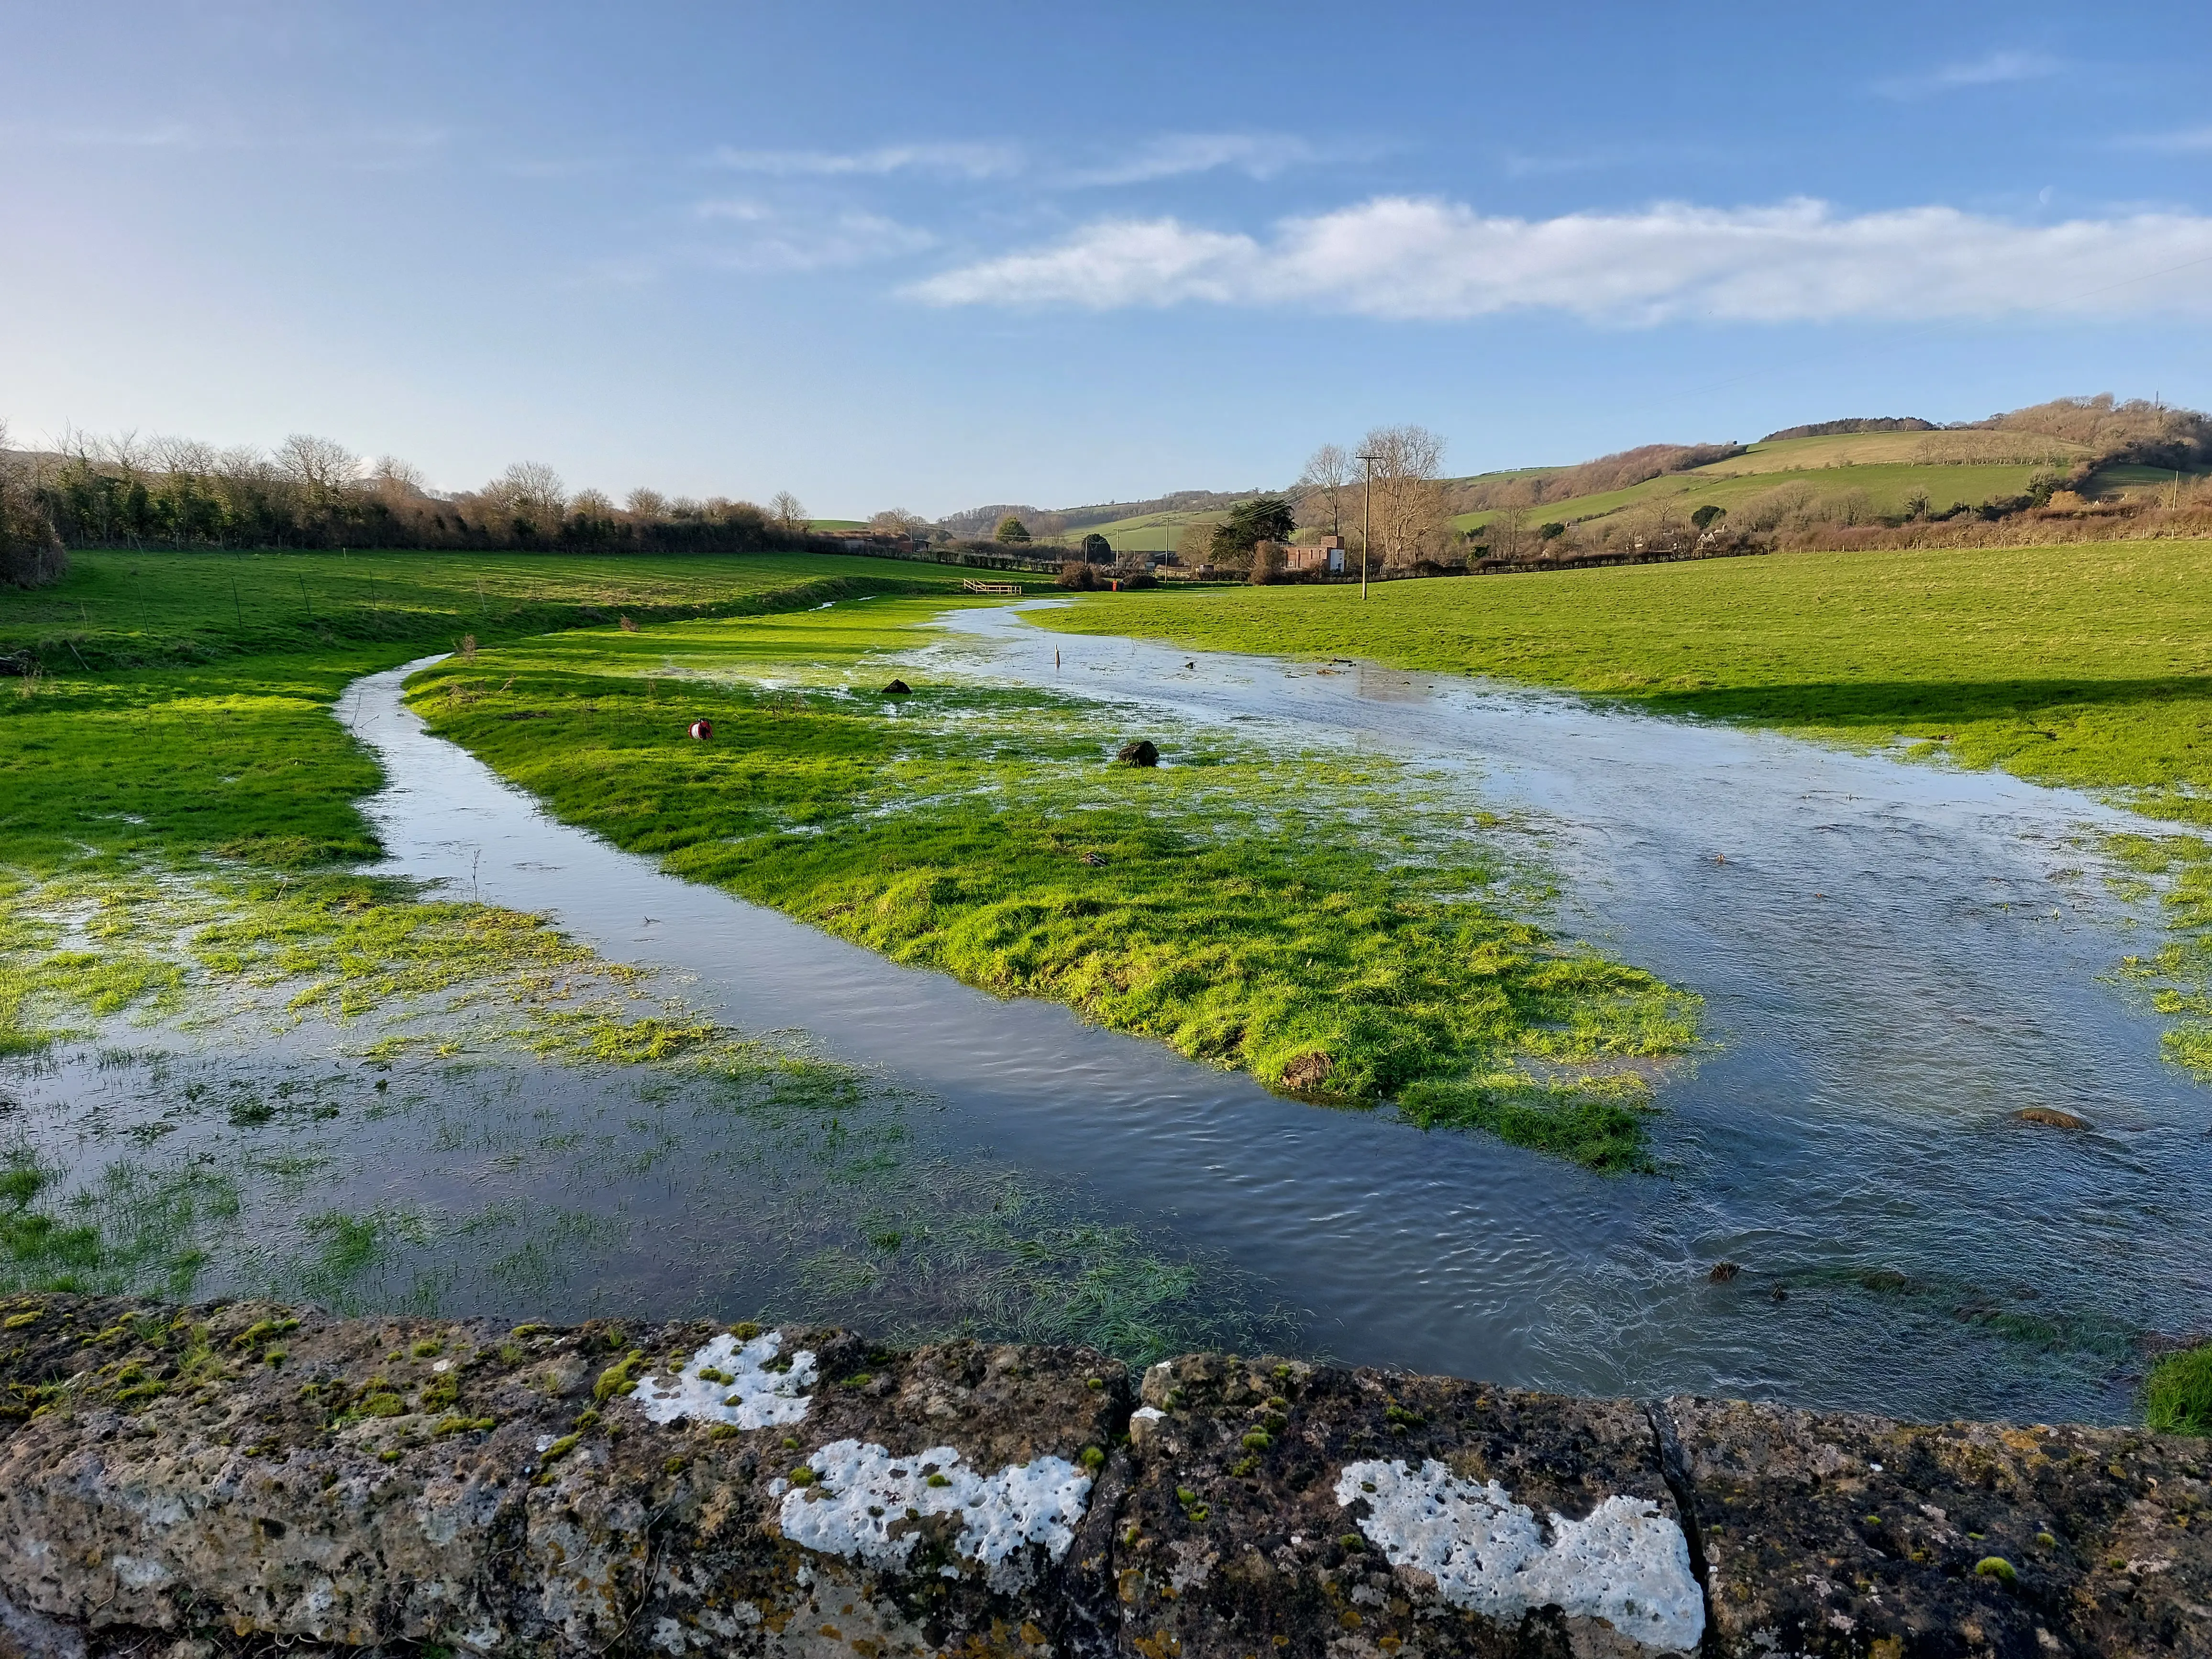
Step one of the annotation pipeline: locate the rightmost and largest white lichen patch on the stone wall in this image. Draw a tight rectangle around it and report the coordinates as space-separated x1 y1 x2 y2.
1336 1458 1705 1652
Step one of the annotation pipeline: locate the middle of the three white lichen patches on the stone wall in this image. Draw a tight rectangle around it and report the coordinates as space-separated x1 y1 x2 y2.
781 1440 1091 1591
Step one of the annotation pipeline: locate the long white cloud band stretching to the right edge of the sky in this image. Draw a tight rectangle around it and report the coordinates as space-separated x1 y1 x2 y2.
907 197 2212 323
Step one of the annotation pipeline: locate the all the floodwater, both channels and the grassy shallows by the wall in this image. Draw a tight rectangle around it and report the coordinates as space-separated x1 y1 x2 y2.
7 610 2212 1420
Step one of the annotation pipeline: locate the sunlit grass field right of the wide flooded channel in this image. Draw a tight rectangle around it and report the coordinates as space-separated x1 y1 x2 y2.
1040 542 2212 1077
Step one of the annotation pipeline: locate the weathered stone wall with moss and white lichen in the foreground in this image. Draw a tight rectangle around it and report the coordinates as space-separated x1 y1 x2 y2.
0 1296 2212 1659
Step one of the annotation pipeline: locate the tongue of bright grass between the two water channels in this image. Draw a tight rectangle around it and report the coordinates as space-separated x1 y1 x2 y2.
411 599 1697 1170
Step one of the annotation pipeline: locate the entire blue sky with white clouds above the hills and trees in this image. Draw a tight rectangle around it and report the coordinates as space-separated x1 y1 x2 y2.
0 0 2212 515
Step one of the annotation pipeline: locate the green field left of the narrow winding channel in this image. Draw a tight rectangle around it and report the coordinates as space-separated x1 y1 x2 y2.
0 553 1018 1026
